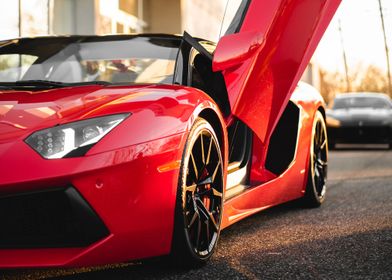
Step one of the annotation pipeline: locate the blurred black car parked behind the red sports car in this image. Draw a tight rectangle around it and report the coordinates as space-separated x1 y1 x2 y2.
327 92 392 149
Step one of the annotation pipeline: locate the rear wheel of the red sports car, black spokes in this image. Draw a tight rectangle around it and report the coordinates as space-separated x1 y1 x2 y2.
303 111 328 208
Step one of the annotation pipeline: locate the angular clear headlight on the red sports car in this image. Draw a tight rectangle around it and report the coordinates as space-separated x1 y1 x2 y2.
25 114 129 159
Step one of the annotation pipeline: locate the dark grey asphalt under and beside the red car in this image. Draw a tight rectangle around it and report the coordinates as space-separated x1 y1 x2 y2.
0 145 392 280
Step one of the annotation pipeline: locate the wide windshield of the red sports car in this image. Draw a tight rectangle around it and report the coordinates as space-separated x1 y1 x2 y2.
0 36 180 84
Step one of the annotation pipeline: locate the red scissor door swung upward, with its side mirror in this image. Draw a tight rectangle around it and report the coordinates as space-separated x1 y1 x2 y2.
213 0 340 143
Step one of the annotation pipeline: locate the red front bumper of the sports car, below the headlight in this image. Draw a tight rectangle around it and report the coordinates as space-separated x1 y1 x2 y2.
0 134 185 268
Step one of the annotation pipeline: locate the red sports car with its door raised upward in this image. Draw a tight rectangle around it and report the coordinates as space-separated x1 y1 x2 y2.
0 0 339 268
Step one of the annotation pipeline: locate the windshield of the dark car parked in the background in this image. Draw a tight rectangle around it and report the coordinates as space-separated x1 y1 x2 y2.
333 96 392 110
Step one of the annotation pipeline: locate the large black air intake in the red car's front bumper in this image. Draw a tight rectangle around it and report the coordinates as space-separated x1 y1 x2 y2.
0 187 109 249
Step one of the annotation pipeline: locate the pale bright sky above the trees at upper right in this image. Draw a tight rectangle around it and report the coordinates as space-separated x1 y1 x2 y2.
313 0 392 72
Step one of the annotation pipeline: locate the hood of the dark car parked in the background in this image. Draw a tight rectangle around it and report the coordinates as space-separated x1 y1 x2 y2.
327 108 392 122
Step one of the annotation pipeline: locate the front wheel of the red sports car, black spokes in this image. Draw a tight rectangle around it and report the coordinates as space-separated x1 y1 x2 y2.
171 118 223 267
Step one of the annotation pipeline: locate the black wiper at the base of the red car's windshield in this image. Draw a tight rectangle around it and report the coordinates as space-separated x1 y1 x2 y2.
0 80 111 89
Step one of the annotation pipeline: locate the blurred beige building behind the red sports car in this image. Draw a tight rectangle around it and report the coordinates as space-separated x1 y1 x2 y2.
0 0 319 88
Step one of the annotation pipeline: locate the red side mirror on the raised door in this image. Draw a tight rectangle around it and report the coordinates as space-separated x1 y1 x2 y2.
212 31 264 72
